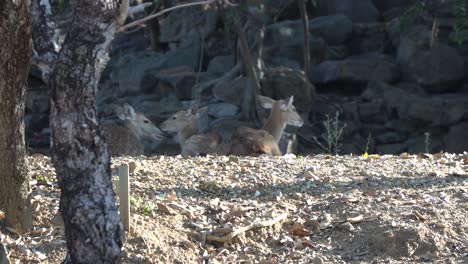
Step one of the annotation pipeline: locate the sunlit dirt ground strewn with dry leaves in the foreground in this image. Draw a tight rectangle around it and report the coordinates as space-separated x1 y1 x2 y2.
0 153 468 263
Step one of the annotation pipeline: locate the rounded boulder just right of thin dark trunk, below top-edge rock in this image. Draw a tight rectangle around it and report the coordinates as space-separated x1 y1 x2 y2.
308 14 353 45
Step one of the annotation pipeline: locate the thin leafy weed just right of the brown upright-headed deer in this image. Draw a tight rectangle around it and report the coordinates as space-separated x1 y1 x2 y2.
313 111 346 155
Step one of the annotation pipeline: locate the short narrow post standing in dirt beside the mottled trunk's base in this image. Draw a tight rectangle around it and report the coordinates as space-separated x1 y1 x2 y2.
119 164 130 232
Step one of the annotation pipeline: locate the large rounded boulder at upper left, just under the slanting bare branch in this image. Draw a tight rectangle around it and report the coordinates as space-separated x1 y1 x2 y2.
159 6 219 47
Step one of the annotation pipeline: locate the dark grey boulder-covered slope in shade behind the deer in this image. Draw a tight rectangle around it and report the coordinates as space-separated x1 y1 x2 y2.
26 0 468 154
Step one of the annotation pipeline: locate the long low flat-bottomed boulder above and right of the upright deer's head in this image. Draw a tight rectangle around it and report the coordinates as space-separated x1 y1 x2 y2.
309 53 400 84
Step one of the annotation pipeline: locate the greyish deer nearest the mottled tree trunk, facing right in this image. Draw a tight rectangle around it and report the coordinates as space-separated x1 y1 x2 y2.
103 103 166 156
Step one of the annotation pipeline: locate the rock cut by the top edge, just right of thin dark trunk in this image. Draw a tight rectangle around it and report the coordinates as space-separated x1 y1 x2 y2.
314 0 379 23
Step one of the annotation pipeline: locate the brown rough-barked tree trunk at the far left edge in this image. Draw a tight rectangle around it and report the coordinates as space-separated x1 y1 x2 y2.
0 0 32 232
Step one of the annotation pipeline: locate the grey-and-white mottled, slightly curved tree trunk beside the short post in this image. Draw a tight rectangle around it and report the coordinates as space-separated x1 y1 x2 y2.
50 0 123 264
